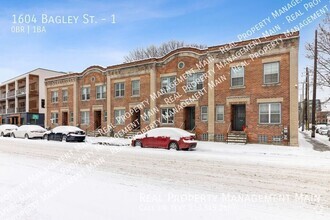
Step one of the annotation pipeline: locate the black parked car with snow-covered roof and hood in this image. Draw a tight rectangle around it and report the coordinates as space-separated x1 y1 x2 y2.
44 126 86 142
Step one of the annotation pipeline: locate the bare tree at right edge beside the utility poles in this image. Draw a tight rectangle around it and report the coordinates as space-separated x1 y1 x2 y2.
306 13 330 89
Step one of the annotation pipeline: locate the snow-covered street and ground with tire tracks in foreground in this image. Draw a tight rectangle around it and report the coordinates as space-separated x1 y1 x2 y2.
0 133 330 220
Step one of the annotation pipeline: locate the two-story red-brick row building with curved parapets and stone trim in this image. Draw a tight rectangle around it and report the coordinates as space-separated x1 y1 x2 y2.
46 33 299 145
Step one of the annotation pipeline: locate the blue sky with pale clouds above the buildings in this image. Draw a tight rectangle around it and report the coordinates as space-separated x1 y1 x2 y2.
0 0 330 108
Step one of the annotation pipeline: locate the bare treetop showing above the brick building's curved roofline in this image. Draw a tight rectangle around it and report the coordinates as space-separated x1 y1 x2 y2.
124 40 207 63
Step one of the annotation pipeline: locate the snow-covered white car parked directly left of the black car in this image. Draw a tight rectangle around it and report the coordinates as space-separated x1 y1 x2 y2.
11 125 47 139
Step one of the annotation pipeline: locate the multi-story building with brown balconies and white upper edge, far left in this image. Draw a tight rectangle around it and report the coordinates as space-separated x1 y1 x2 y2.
0 68 64 126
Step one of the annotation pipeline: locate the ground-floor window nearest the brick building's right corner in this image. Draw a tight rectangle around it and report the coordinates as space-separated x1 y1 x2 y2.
259 103 281 124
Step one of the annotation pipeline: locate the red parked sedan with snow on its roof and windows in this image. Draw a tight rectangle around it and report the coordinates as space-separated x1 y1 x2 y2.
132 128 197 150
